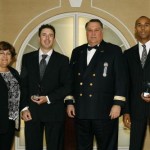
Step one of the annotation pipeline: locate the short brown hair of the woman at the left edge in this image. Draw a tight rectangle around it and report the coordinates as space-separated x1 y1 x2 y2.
0 41 16 57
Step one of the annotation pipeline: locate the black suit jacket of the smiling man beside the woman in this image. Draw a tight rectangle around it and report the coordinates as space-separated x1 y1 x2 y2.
21 51 71 121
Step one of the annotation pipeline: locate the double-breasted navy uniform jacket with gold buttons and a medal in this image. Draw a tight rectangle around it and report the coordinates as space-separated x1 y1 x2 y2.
66 41 127 119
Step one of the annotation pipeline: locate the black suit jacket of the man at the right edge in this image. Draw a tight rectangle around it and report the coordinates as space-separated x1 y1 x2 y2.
124 45 150 120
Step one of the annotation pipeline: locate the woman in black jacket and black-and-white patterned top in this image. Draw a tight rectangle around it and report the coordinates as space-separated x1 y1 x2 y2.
0 41 20 150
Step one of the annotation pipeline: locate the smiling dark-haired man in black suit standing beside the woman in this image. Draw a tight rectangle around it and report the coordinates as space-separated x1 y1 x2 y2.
21 24 71 150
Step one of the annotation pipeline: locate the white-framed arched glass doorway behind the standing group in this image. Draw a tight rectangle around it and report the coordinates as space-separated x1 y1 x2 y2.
16 12 129 150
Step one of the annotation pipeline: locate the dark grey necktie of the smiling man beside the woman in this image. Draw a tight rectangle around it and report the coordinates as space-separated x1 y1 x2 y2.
40 54 47 79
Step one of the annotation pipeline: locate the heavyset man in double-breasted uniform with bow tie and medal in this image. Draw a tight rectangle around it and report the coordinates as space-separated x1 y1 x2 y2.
65 19 127 150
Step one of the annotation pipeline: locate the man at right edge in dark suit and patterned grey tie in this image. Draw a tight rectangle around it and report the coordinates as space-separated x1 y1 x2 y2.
123 16 150 150
